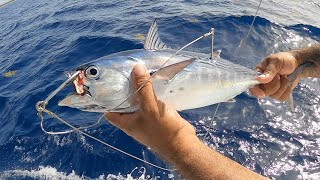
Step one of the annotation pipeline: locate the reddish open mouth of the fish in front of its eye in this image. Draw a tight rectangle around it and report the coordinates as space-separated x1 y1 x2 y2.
65 70 92 97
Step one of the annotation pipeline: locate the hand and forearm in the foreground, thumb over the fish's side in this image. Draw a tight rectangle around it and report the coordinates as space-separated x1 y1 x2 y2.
105 65 263 179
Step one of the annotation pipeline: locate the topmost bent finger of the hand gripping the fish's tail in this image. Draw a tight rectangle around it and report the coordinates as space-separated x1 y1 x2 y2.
257 56 282 84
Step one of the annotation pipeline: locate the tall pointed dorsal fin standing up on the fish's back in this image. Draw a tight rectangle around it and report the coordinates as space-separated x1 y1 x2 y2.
143 19 167 50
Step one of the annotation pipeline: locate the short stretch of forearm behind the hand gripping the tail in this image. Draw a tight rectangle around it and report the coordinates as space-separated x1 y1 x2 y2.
290 44 320 77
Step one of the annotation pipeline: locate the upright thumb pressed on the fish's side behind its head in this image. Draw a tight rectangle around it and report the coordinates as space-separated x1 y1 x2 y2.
131 64 157 112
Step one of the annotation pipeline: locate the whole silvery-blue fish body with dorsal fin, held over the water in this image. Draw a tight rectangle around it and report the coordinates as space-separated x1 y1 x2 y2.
59 21 259 112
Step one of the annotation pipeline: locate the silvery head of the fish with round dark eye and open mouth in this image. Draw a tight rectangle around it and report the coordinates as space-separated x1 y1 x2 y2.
58 61 130 112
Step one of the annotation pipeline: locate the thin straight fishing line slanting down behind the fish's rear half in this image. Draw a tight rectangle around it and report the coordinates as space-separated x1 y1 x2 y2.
202 0 262 141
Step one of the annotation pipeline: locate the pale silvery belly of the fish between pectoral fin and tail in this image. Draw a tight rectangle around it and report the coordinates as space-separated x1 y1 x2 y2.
156 62 258 110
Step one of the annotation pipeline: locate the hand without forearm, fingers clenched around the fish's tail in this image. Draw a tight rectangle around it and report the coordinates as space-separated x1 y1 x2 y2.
250 52 302 101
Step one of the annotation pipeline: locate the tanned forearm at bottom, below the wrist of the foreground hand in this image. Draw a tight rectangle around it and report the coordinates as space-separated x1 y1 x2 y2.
166 135 264 180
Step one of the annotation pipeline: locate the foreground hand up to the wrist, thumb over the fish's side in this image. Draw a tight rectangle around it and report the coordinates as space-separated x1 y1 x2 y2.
105 64 196 161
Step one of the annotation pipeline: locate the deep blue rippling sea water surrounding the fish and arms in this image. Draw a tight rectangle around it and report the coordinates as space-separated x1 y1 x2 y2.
0 0 320 179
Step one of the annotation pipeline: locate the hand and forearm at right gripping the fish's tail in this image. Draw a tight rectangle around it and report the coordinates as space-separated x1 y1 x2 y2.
250 45 320 101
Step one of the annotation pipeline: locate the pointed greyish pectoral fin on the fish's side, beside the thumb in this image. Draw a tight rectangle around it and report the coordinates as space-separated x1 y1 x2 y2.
153 58 196 80
